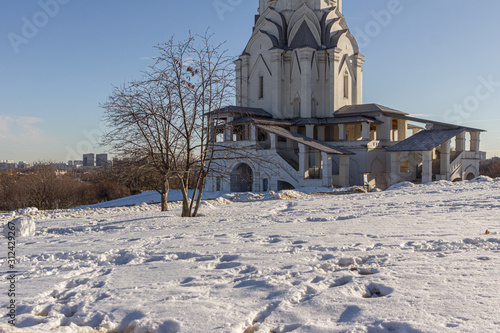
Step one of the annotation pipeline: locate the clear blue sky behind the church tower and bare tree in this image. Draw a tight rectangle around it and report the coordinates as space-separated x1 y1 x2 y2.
0 0 500 161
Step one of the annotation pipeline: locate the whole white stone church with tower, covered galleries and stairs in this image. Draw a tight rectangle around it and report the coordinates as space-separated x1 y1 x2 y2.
207 0 482 192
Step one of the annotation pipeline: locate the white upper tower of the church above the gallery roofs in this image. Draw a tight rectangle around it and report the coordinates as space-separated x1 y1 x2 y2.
235 0 364 119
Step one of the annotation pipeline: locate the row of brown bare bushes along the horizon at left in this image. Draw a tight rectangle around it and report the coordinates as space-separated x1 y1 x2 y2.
0 161 203 211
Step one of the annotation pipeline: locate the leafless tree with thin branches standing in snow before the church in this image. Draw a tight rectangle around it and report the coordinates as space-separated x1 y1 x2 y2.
102 34 234 217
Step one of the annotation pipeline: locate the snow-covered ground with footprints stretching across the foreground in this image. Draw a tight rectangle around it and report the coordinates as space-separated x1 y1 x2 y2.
0 181 500 333
